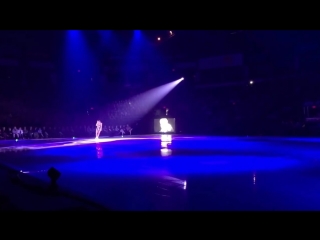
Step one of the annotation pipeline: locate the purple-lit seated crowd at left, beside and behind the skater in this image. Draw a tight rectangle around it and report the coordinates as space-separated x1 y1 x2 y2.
0 97 136 140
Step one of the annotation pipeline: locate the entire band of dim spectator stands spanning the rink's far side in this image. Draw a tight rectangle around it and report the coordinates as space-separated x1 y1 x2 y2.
0 72 320 139
